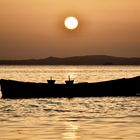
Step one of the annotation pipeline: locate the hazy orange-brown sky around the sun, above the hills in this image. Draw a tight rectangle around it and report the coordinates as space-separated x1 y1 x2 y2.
0 0 140 59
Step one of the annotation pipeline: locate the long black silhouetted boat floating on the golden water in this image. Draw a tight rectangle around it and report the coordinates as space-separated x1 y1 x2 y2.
0 76 140 99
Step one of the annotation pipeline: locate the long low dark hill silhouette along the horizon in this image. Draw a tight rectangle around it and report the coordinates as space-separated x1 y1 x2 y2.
0 55 140 65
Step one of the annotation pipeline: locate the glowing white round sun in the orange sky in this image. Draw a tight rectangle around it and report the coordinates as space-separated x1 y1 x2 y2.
64 17 78 30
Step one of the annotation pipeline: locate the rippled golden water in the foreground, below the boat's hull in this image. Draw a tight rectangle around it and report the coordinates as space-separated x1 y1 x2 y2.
0 97 140 140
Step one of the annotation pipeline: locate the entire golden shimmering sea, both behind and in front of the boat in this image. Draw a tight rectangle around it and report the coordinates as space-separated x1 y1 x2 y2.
0 66 140 140
